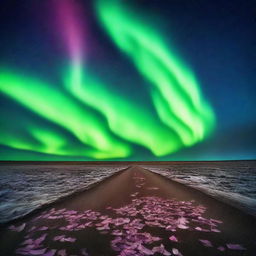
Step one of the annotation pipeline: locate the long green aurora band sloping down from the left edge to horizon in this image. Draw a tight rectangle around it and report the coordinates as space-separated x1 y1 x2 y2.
0 70 131 158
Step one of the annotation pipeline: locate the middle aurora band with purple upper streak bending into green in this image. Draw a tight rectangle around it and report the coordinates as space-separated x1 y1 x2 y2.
58 1 182 156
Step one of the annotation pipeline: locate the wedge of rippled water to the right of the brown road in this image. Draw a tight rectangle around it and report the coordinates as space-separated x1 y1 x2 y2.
145 161 256 216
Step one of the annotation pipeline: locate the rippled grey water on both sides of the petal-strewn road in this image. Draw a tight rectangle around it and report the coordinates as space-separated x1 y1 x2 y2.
0 161 256 223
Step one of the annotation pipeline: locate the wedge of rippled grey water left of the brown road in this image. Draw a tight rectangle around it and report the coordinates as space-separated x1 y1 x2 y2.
0 165 125 223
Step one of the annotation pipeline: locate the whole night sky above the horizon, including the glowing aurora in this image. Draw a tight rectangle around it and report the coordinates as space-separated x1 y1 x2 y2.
0 0 256 161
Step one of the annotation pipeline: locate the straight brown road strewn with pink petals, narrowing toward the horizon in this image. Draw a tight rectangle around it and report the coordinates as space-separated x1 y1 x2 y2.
0 167 256 256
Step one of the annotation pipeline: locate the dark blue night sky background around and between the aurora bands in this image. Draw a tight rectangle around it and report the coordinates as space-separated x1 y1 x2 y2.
0 0 256 160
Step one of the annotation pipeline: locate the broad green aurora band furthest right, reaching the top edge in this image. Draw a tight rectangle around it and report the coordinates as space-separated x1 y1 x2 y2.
96 0 214 145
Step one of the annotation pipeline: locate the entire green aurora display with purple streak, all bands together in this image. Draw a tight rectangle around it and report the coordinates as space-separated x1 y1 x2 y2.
0 0 215 160
